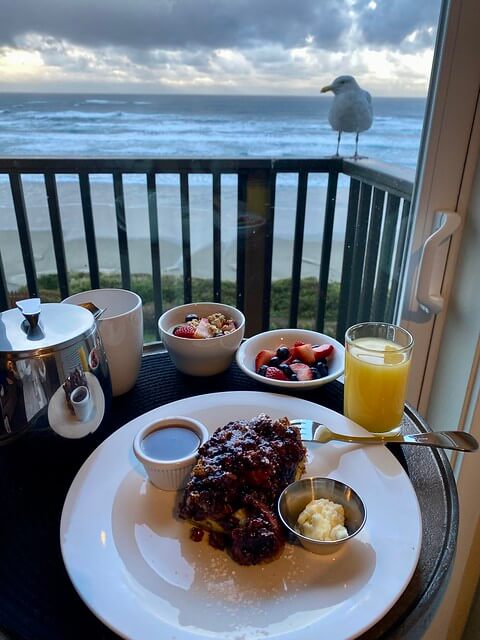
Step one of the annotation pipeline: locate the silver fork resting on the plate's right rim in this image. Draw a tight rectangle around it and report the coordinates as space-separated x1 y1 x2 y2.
290 418 478 452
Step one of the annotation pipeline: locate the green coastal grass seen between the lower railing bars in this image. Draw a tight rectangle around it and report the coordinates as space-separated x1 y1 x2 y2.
11 272 340 343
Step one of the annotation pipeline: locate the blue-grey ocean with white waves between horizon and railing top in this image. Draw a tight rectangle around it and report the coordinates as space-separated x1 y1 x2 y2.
0 93 425 168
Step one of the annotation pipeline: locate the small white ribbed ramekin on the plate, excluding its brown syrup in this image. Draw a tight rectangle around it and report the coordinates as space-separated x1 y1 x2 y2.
133 416 210 491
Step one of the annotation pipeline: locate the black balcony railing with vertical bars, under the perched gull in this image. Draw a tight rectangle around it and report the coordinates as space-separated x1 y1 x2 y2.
0 158 413 340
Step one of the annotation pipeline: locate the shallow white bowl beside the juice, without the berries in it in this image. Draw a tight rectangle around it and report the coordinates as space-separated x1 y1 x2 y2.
236 329 345 389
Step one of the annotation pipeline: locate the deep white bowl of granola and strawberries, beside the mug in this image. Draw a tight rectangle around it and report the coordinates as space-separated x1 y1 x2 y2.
158 302 245 376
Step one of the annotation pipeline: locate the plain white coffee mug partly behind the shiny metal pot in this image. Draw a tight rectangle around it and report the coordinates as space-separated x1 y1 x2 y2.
62 289 143 396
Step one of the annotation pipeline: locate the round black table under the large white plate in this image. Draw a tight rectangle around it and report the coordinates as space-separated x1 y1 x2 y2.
0 353 458 640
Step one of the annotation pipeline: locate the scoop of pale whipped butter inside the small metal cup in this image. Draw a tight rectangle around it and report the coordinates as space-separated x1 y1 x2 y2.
297 498 348 542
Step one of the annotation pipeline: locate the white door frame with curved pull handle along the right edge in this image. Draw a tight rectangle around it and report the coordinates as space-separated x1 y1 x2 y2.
402 0 480 640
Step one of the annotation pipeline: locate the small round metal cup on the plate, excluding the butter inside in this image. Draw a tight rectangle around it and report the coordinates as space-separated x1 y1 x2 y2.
278 477 367 554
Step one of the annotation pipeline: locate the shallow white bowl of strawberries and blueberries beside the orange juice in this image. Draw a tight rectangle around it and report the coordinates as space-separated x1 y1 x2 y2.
236 329 345 388
